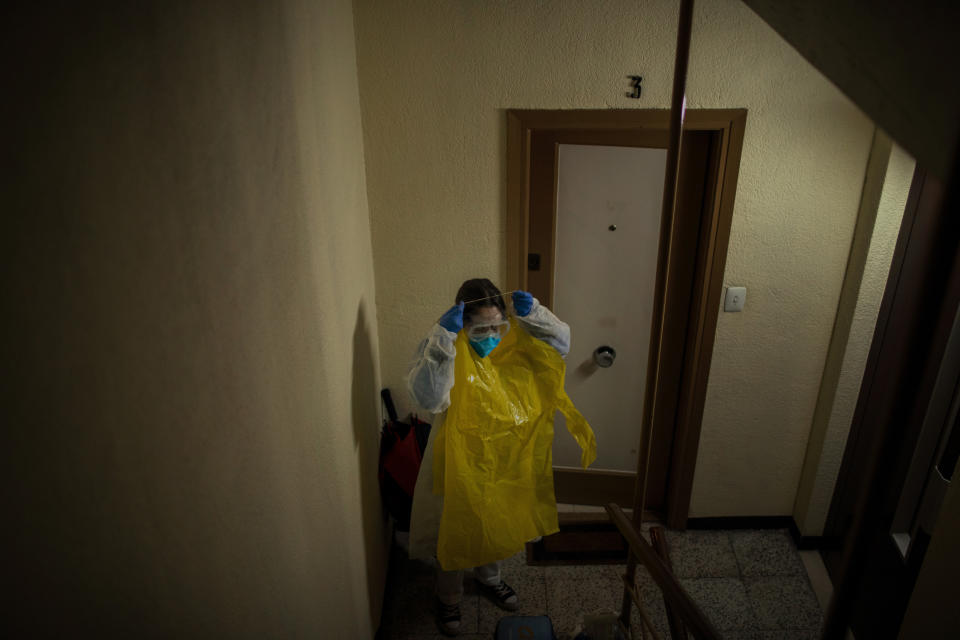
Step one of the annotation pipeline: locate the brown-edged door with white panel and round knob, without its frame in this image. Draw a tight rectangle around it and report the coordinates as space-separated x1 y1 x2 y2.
530 131 715 517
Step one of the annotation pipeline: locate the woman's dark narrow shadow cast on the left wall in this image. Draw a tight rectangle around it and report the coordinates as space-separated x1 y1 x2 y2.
350 298 389 626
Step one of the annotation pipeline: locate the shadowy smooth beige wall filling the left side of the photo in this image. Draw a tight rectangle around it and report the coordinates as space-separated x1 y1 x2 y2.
0 0 386 638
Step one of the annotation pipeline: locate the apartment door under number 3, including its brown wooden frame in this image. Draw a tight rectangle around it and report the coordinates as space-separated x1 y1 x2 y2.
507 110 746 527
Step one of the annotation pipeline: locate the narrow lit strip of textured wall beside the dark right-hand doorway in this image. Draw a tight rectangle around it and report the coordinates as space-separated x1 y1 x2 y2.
794 138 915 536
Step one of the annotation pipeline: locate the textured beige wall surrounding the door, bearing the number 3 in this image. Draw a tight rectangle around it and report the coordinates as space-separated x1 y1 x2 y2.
354 0 872 516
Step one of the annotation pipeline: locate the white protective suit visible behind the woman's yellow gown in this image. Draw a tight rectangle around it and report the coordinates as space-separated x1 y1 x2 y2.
407 298 570 560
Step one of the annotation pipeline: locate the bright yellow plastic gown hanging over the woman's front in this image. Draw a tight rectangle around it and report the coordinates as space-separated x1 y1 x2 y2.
434 320 597 571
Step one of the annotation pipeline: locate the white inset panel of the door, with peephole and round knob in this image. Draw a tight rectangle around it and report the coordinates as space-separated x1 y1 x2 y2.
553 144 667 472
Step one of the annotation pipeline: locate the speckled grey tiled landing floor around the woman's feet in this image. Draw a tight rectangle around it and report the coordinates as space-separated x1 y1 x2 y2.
381 530 829 640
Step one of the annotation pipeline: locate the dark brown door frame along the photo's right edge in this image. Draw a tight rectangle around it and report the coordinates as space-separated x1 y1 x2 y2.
821 166 960 637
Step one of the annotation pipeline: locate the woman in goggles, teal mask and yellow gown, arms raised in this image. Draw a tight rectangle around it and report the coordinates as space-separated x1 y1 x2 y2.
408 278 596 635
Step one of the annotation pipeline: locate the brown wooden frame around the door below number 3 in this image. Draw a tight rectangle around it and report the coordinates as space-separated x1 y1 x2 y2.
505 109 747 529
